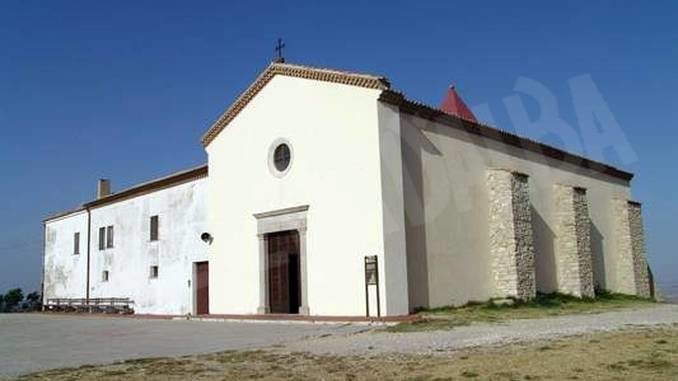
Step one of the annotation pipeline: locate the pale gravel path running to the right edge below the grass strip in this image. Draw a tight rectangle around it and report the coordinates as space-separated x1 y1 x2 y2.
285 304 678 355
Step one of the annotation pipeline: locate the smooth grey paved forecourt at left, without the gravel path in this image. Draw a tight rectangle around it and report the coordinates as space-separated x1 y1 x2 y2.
0 314 366 377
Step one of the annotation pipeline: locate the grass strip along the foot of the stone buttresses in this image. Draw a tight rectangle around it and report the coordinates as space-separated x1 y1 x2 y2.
386 291 656 332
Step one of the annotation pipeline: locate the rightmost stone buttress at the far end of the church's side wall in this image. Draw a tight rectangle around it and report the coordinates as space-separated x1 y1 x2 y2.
612 199 650 297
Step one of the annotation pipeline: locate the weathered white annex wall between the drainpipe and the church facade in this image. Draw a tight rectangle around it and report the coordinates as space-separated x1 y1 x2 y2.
90 179 207 314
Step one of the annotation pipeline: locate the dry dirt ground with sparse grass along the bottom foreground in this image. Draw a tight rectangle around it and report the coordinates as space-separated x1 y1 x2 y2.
15 324 678 381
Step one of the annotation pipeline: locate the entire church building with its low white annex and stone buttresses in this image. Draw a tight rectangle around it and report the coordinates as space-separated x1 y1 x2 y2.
43 62 651 317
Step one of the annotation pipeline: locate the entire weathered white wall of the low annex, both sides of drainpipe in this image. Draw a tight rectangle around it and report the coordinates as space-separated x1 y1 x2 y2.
45 179 207 314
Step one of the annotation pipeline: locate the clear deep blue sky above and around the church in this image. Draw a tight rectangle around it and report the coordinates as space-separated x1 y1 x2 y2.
0 0 678 292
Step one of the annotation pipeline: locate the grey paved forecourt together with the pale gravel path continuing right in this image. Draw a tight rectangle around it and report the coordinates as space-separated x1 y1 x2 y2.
0 305 678 378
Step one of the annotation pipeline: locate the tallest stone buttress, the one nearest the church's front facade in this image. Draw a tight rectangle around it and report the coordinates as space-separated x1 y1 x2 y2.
487 169 536 300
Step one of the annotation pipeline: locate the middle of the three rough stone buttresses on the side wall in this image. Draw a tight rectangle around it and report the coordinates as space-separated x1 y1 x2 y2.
553 185 595 297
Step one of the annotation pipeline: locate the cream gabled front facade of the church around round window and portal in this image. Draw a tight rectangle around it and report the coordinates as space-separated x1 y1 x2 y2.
207 76 408 316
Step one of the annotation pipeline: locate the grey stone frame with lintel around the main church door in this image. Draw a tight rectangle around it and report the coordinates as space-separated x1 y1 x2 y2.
254 205 310 315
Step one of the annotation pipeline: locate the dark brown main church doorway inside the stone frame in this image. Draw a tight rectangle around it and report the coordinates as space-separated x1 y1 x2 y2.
268 230 301 314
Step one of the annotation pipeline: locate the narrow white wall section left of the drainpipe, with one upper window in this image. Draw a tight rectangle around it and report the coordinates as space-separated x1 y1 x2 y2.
43 211 87 299
